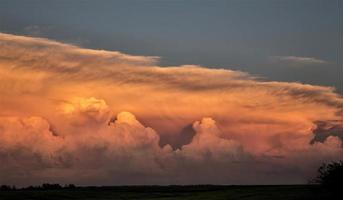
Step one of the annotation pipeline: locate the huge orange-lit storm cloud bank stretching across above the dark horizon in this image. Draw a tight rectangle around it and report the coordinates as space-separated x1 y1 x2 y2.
0 34 343 185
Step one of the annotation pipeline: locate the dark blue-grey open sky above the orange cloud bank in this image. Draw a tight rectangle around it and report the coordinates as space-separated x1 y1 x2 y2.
0 0 343 94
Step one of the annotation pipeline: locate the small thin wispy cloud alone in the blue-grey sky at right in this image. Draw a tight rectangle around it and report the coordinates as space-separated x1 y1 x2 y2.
270 56 328 65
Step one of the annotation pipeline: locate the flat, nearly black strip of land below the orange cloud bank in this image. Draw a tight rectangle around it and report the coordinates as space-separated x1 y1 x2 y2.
0 185 343 200
